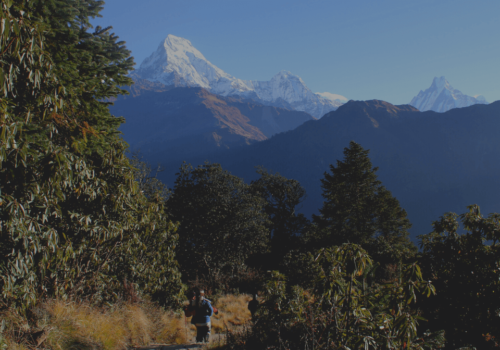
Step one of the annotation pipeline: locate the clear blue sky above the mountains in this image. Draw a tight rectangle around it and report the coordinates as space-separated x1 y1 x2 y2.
92 0 500 104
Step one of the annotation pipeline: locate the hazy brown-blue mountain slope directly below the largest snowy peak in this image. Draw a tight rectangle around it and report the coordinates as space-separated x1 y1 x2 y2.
110 79 315 161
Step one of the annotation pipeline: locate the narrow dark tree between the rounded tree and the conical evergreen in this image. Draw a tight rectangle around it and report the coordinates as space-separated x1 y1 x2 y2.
250 168 309 267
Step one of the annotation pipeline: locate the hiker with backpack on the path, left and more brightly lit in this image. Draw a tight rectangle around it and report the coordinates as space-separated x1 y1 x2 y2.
184 290 214 343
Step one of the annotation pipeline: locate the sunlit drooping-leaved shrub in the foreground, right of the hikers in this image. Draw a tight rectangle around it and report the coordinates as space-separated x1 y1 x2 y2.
244 244 442 349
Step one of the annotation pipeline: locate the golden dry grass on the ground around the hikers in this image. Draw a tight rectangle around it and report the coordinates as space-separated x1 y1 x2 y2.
0 295 251 350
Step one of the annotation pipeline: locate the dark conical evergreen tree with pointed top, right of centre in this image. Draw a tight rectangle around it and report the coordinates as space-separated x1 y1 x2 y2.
313 141 416 262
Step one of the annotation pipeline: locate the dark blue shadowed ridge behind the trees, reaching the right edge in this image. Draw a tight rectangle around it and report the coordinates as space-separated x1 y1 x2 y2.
151 100 500 239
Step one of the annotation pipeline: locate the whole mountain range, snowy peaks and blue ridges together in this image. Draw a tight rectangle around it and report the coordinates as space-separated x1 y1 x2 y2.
110 35 500 242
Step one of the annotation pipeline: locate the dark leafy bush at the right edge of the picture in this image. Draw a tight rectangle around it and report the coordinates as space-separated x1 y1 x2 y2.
419 205 500 349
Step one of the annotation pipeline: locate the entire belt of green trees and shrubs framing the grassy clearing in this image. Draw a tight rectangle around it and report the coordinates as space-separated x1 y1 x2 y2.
0 0 500 349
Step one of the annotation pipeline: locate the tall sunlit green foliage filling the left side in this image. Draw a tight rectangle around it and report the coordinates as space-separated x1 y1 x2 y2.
0 0 181 308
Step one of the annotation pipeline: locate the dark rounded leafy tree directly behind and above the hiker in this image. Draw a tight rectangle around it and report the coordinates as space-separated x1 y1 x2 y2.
168 164 268 288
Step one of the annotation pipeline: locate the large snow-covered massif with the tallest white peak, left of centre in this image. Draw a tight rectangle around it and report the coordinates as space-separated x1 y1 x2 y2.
134 34 347 118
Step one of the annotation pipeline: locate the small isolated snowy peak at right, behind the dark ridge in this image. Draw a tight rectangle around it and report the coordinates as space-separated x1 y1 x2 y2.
410 77 488 112
